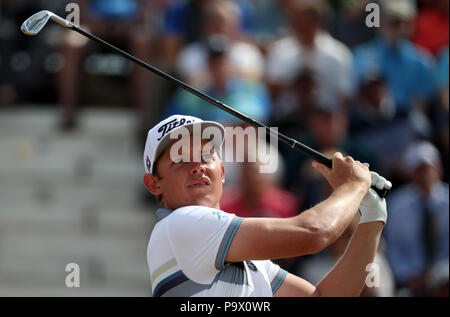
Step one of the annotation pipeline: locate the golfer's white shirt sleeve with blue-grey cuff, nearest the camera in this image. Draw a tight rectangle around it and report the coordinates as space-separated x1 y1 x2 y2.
167 206 242 284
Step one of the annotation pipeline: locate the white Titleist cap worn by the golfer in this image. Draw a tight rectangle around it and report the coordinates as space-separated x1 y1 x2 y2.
144 114 225 174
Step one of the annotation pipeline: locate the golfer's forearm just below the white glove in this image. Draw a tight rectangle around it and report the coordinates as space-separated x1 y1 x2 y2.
316 221 384 297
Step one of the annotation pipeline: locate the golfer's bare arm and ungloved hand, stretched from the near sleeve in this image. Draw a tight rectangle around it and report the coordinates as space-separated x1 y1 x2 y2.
225 153 371 262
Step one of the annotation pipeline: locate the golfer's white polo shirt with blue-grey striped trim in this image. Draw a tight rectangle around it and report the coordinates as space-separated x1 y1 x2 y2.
147 206 287 297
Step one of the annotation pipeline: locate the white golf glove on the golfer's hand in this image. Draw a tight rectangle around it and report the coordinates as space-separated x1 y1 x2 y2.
359 172 392 224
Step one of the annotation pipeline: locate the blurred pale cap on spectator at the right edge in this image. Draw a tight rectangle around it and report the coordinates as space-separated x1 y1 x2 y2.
403 141 440 173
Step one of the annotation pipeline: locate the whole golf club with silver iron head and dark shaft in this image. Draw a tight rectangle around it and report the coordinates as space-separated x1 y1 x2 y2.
21 10 389 198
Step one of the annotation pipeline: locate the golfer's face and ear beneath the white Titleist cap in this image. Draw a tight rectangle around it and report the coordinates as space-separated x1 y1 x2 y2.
144 137 225 210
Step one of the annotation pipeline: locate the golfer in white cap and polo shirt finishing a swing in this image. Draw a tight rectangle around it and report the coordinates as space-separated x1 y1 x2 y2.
144 115 392 297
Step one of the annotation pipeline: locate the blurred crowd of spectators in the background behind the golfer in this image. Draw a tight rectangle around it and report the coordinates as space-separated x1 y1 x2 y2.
0 0 449 296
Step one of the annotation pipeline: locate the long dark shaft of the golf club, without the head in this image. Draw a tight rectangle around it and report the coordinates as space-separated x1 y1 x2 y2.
69 25 389 198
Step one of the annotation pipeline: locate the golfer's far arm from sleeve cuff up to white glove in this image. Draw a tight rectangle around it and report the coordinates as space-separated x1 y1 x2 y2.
274 221 384 297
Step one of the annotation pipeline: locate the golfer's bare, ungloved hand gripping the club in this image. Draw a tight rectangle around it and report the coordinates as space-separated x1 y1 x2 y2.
313 152 371 191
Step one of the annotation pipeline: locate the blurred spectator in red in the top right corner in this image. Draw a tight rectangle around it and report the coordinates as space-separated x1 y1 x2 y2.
412 0 449 56
